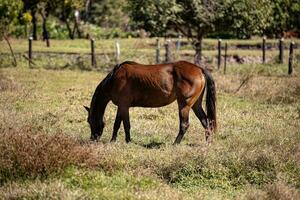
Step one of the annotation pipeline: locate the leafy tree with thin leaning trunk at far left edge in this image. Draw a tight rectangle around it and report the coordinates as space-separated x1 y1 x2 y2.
0 0 23 66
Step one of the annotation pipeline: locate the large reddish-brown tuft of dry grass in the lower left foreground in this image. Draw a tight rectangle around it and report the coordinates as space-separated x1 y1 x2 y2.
0 127 98 184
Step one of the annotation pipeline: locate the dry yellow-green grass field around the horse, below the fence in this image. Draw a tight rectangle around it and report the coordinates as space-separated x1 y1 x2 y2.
0 38 300 199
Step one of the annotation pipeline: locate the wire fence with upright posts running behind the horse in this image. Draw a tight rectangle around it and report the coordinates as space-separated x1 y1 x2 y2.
0 38 300 72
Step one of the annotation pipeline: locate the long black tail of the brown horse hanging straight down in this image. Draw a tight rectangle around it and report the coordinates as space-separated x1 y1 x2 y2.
204 70 217 130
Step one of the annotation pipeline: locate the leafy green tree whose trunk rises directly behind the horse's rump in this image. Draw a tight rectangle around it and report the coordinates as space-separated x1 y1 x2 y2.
127 0 223 64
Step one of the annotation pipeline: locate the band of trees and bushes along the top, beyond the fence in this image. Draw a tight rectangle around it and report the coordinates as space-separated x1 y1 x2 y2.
0 0 300 40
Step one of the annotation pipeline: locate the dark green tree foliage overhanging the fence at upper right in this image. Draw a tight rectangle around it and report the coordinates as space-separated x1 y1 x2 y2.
127 0 300 40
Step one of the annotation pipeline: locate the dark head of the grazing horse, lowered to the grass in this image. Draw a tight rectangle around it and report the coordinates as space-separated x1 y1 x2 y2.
84 106 105 141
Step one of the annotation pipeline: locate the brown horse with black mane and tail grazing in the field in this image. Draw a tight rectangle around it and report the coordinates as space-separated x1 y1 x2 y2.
85 61 216 144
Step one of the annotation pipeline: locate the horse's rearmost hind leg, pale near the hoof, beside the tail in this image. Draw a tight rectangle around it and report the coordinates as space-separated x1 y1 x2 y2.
193 100 212 143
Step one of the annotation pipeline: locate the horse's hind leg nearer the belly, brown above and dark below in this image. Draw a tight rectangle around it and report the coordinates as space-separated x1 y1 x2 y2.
174 103 191 144
